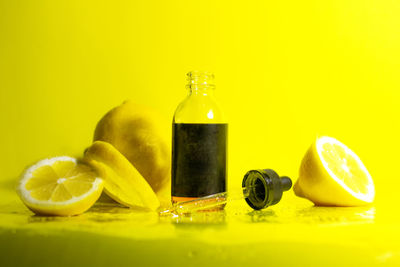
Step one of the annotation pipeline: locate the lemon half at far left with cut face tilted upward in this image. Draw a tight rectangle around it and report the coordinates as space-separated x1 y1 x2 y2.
17 156 103 216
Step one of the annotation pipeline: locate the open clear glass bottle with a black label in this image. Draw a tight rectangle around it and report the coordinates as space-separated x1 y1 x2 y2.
171 71 228 203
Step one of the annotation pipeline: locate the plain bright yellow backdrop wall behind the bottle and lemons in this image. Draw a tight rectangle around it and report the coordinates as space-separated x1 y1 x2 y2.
0 0 400 207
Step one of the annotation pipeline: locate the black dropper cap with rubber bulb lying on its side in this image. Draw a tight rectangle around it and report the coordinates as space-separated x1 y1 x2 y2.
242 169 292 210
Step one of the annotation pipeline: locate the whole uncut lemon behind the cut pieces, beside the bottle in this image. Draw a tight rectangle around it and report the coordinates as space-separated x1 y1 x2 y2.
93 101 171 203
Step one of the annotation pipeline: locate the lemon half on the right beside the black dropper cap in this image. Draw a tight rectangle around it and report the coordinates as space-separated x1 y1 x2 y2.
293 136 375 206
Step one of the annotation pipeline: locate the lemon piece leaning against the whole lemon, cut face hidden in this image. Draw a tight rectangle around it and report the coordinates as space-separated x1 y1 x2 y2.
85 141 160 210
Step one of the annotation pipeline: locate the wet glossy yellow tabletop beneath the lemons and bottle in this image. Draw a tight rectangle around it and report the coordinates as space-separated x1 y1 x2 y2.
0 185 400 266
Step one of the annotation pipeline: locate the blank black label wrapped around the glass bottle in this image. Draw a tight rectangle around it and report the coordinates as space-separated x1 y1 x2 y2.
171 123 228 201
